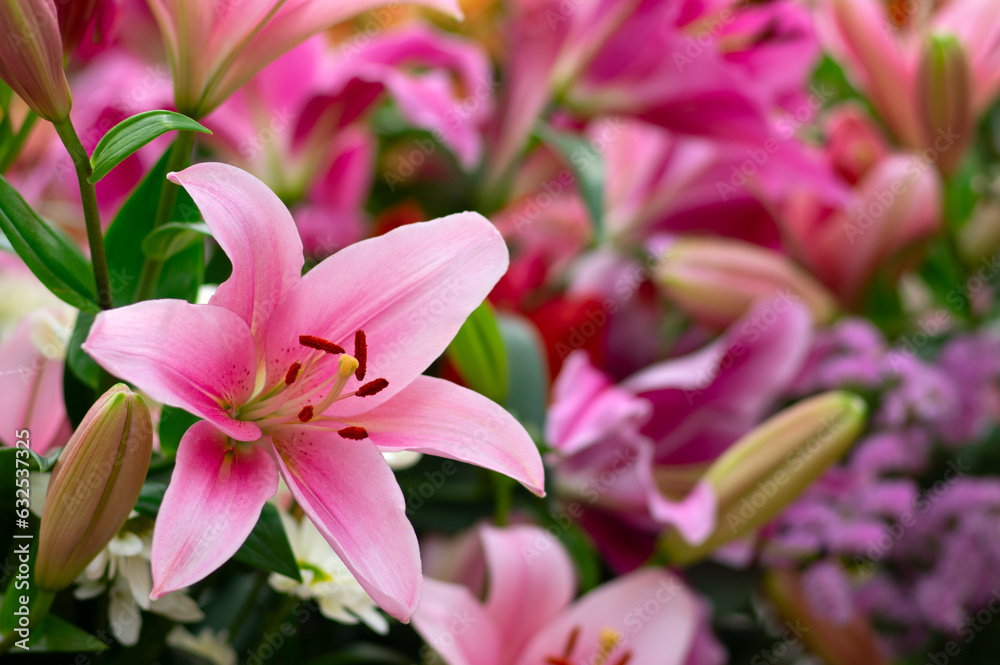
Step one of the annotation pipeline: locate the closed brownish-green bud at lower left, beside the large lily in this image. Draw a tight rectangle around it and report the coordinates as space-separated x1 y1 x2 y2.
35 384 153 591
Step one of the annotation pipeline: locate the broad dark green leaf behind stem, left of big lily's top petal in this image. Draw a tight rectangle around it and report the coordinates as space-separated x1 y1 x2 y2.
104 144 200 307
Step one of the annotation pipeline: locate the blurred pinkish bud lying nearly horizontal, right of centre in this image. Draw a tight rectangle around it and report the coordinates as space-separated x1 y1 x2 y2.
656 237 837 328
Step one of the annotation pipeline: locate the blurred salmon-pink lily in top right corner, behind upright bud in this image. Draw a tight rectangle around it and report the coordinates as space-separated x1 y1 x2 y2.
817 0 1000 156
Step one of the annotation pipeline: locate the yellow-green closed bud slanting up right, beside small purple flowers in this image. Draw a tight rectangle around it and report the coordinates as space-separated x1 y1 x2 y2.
663 391 867 565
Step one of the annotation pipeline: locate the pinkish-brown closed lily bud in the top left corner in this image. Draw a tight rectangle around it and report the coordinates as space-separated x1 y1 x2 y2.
0 0 73 122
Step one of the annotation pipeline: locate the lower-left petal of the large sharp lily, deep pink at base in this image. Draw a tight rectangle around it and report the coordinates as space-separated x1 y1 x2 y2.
151 421 278 600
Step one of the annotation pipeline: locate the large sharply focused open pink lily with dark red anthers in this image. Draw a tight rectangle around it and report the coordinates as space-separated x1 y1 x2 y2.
83 163 544 620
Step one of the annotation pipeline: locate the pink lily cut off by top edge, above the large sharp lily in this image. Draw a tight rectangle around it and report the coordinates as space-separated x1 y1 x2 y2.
149 0 462 118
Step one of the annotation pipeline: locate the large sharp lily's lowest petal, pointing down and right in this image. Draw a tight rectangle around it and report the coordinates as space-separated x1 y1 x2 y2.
274 430 421 621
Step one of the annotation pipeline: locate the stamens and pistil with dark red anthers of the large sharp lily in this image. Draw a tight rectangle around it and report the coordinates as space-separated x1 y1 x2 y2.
237 330 389 441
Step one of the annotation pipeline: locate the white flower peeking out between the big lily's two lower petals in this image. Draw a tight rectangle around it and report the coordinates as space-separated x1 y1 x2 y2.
268 511 389 635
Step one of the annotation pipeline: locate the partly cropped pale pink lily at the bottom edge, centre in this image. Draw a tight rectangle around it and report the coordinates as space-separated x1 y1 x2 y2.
413 525 726 665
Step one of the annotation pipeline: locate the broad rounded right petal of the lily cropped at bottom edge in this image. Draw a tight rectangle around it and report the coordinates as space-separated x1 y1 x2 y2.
516 569 698 665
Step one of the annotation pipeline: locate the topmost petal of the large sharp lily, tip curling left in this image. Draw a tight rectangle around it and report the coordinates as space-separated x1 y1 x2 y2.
168 162 303 340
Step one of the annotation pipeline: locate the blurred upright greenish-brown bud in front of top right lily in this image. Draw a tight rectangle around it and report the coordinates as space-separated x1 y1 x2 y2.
917 35 975 175
